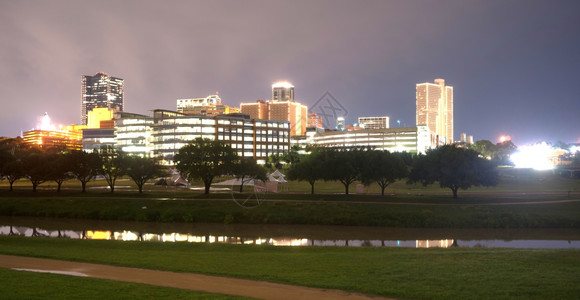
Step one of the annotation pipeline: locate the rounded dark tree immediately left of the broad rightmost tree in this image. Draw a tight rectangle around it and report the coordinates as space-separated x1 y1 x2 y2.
361 150 409 196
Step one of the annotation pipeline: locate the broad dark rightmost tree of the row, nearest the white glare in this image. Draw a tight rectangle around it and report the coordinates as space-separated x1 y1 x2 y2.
408 145 498 198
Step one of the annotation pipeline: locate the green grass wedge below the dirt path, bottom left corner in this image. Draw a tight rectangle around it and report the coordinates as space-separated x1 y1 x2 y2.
0 269 248 300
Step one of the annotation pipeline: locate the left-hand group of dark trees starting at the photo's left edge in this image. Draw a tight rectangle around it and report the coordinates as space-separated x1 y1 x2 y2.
0 138 167 193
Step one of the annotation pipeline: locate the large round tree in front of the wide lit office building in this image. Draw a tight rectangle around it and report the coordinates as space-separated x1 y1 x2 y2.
173 138 238 194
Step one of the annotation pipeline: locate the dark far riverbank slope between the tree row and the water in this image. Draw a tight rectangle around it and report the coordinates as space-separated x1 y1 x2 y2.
0 191 580 228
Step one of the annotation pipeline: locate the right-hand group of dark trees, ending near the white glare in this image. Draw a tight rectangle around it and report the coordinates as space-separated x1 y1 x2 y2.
288 145 498 198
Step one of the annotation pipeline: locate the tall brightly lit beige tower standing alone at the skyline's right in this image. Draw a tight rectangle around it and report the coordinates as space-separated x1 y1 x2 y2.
416 79 453 144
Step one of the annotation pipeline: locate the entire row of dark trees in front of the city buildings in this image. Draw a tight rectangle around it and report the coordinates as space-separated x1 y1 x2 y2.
0 138 498 198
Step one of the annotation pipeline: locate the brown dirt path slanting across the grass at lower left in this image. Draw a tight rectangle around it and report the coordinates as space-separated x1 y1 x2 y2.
0 255 387 300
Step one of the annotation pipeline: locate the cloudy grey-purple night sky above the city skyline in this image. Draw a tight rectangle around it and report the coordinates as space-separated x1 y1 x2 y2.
0 0 580 146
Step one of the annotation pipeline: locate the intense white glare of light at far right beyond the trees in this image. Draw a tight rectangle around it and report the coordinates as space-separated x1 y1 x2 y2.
510 142 557 170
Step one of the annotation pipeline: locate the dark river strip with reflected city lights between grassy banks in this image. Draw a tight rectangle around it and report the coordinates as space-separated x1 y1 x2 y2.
0 218 580 249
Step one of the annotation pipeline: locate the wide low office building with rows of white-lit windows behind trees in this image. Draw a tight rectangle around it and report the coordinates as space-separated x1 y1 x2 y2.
109 109 290 165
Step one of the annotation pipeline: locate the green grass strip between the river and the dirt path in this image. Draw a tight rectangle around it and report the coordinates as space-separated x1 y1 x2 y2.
0 237 580 299
